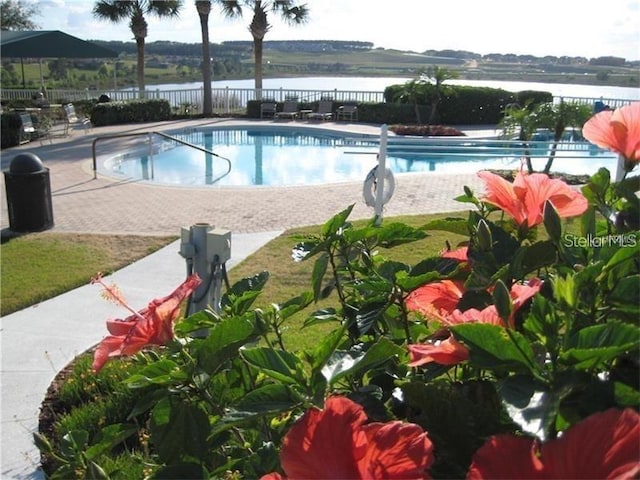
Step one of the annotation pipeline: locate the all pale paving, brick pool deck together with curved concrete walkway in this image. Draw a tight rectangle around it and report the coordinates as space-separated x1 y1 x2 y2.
0 119 495 480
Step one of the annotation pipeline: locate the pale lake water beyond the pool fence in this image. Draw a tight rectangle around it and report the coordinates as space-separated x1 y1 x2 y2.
147 77 640 100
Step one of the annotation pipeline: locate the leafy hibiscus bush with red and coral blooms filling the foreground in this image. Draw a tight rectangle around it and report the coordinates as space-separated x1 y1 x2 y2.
39 103 640 480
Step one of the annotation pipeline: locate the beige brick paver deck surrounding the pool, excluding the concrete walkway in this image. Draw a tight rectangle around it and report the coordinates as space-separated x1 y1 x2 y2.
0 119 496 235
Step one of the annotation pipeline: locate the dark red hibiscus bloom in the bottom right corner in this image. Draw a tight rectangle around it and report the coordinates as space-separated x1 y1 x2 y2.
467 408 640 480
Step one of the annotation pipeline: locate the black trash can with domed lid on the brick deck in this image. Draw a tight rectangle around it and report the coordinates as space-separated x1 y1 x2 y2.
4 153 53 232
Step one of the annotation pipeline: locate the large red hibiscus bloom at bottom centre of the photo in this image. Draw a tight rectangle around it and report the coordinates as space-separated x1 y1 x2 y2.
262 396 433 480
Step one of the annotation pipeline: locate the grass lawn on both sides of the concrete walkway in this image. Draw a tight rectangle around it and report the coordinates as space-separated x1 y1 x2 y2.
0 213 465 348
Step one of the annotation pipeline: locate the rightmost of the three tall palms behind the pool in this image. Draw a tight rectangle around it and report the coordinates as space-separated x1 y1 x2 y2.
222 0 309 91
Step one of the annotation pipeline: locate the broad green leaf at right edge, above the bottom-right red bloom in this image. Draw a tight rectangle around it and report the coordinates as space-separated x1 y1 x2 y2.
560 322 640 369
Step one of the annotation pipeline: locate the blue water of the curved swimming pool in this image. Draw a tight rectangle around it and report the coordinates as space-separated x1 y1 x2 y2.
98 125 616 186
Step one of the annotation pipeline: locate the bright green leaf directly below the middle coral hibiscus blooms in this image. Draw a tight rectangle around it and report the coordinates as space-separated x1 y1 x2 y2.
451 323 535 371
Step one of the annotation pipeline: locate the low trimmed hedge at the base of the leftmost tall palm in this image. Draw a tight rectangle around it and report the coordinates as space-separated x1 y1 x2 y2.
91 100 171 127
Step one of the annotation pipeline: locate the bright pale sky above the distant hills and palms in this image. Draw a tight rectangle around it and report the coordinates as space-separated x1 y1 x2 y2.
24 0 640 60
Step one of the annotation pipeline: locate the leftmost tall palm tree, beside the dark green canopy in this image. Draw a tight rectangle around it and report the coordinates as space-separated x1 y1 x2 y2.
93 0 182 96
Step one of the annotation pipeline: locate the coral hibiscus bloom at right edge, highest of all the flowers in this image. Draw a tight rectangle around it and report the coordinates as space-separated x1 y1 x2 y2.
582 102 640 172
